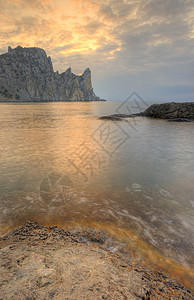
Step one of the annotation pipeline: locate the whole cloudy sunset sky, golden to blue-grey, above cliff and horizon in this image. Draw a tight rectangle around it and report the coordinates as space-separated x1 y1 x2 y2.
0 0 194 101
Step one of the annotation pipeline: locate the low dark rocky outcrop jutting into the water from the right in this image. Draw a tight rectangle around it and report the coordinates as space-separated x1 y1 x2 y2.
100 102 194 122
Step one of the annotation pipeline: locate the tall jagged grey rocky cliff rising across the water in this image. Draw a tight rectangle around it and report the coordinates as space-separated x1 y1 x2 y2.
0 46 100 101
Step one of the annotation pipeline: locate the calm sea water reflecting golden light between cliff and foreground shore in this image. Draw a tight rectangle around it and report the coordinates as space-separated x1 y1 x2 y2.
0 102 194 288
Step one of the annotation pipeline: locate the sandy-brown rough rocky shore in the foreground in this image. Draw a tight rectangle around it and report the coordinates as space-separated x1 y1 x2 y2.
0 222 193 300
